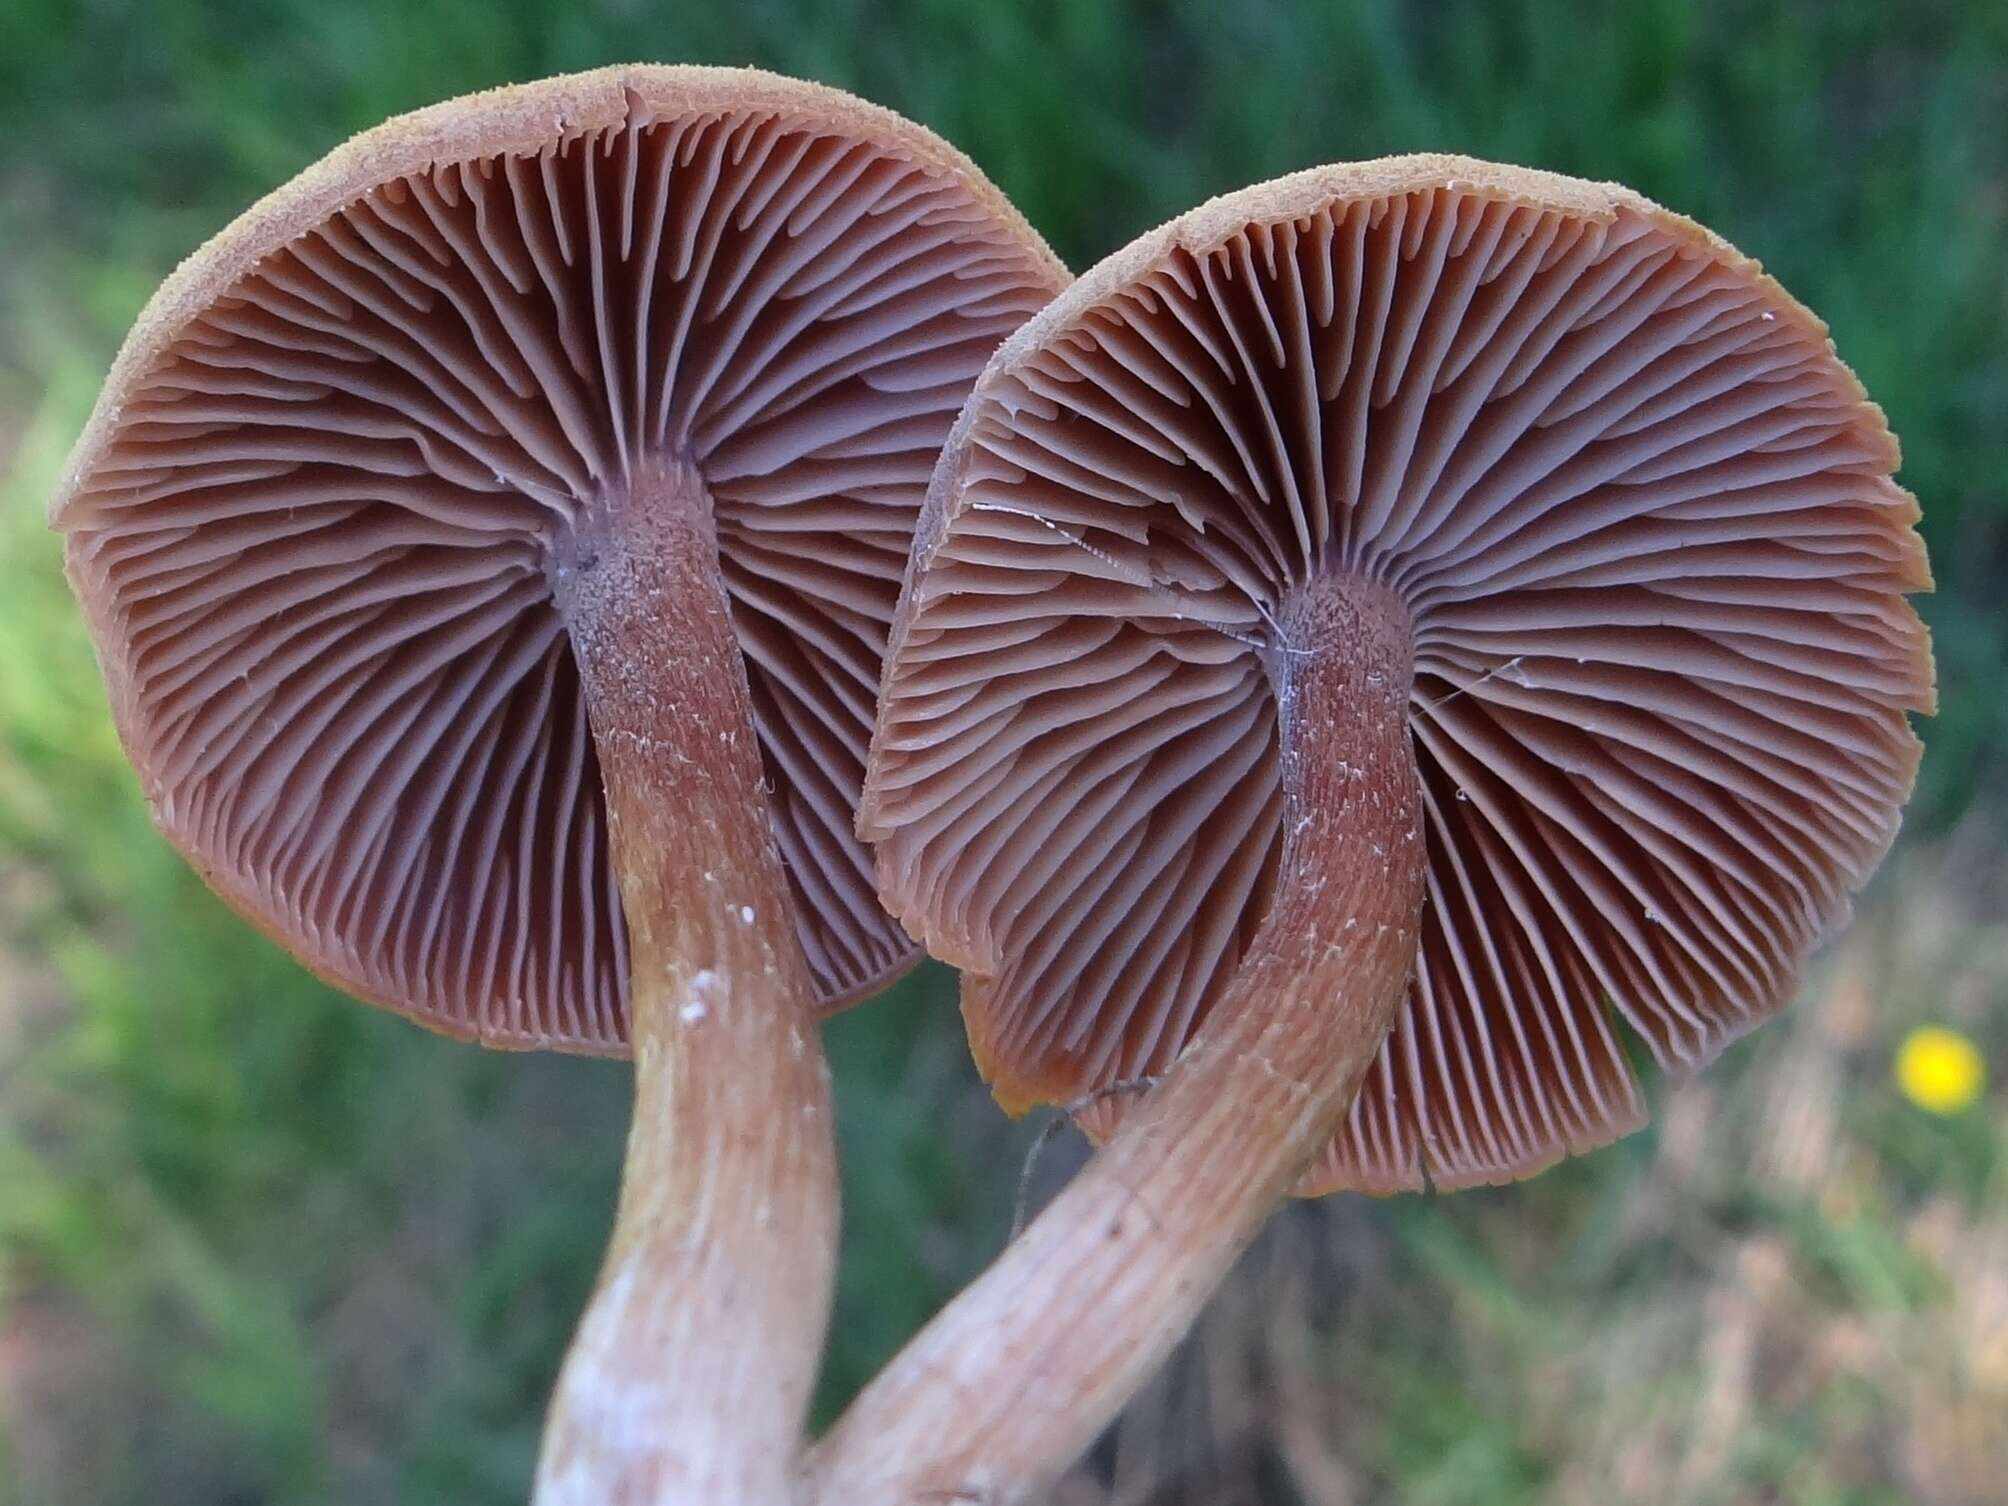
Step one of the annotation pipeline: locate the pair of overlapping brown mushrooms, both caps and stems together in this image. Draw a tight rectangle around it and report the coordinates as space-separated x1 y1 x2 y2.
52 68 1932 1506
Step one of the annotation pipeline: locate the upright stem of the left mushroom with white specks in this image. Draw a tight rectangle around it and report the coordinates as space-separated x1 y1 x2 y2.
536 468 837 1506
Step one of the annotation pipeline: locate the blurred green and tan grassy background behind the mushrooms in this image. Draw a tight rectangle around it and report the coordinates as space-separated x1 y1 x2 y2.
0 0 2008 1506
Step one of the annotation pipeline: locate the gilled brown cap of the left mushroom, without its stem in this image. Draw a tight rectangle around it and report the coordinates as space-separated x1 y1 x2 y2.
50 66 1066 1052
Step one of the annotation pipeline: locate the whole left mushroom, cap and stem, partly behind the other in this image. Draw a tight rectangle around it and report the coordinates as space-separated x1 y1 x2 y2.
52 66 1064 1502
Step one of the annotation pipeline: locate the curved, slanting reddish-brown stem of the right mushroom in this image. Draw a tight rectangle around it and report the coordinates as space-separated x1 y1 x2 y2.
807 574 1424 1506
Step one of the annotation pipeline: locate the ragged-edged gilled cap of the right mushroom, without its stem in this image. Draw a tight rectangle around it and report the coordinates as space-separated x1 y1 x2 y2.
859 157 1932 1191
